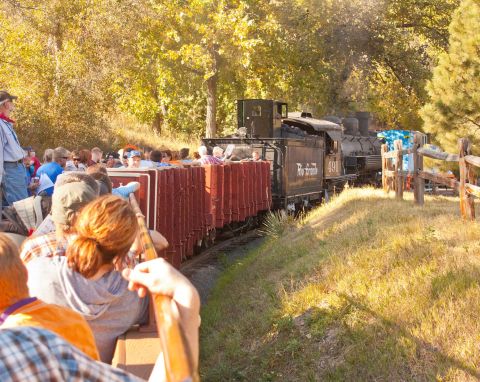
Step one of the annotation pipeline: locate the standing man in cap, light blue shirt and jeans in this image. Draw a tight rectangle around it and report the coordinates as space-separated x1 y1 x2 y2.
0 90 28 205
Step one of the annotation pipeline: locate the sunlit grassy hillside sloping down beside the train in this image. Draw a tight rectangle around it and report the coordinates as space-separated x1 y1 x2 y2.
201 189 480 381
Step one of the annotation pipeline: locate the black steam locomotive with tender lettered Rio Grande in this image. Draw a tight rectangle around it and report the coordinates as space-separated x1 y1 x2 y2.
203 99 382 210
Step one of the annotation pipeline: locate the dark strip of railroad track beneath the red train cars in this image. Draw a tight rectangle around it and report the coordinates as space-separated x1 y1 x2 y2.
180 229 263 278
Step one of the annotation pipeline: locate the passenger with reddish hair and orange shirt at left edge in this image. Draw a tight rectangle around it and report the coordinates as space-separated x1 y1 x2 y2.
0 234 100 360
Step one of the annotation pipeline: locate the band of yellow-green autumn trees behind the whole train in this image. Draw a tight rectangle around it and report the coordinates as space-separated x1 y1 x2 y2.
0 0 464 146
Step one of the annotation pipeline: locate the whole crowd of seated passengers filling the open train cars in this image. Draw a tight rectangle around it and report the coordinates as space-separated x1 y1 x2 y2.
0 137 266 381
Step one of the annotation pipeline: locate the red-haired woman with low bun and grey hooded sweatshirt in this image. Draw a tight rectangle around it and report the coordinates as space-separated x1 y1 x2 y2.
22 195 148 363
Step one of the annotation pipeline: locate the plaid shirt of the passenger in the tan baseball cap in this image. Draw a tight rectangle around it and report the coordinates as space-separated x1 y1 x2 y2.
20 232 68 264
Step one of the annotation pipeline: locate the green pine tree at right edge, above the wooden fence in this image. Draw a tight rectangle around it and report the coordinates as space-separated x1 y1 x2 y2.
422 0 480 151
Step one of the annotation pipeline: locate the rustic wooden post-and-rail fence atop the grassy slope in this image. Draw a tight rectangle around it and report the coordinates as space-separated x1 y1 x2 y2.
382 133 480 220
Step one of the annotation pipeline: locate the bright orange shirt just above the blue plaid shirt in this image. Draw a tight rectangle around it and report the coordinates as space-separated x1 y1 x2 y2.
1 300 100 360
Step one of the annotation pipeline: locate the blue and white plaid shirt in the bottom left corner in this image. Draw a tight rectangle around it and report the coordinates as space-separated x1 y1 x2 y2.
0 327 142 382
